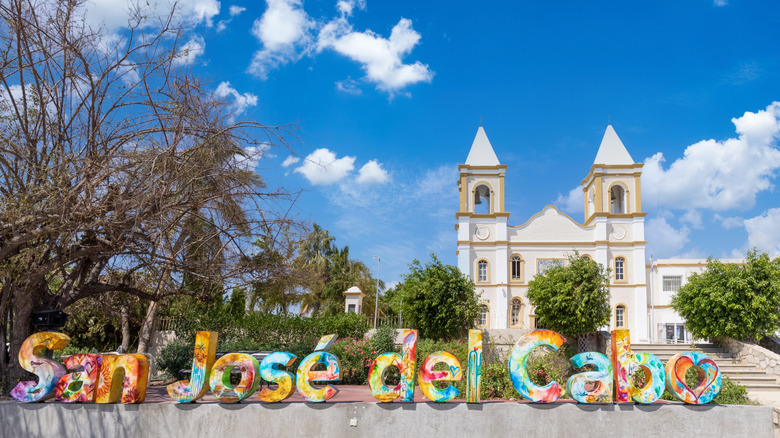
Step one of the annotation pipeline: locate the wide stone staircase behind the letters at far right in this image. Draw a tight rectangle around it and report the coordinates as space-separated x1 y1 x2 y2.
631 343 780 393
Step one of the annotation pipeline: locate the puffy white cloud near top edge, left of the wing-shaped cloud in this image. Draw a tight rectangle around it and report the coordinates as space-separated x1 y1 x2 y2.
247 0 316 79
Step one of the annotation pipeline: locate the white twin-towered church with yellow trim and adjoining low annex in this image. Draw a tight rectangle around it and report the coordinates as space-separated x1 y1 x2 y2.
455 125 728 342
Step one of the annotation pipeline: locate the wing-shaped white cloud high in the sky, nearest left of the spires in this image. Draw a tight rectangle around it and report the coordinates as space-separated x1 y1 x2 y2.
317 17 433 95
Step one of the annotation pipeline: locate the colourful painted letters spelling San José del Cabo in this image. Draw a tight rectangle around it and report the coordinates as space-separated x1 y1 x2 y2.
11 330 721 404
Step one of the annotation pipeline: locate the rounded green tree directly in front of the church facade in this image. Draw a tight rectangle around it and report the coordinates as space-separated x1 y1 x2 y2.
528 252 610 338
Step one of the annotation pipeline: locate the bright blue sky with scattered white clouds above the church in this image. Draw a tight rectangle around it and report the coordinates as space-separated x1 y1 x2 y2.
88 0 780 283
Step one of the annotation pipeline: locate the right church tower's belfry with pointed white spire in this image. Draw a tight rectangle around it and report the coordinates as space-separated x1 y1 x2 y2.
580 125 646 225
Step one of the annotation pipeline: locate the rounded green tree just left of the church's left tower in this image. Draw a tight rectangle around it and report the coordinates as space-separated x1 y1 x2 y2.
393 254 479 339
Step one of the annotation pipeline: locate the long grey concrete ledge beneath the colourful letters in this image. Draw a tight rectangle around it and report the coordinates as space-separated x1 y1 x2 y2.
0 402 773 438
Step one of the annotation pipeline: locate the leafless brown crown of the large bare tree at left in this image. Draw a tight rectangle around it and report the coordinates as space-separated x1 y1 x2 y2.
0 0 286 384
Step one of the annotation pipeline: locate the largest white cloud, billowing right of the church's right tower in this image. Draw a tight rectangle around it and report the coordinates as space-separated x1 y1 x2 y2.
642 102 780 210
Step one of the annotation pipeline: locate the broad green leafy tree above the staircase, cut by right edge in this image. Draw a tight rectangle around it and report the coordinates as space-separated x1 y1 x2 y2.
672 250 780 341
